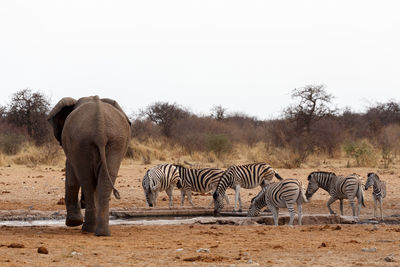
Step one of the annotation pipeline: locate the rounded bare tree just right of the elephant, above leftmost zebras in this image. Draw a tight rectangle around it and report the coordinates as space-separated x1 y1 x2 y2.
142 102 189 137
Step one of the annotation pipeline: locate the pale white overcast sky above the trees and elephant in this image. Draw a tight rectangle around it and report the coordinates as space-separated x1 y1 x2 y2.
0 0 400 119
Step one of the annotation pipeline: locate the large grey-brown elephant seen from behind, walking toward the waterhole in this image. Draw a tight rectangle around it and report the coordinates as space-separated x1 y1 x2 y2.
48 96 131 236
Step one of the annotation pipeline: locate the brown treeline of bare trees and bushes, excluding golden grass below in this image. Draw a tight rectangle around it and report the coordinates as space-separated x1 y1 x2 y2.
0 85 400 167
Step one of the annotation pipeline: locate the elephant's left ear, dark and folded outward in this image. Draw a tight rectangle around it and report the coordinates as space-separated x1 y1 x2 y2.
47 97 76 145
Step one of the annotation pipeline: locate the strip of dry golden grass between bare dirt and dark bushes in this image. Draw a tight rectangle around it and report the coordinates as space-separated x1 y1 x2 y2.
0 139 397 169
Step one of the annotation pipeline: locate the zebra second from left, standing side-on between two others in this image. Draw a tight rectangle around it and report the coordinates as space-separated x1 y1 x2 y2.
175 165 229 206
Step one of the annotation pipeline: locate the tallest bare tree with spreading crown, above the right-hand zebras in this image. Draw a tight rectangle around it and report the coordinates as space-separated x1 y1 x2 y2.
284 84 336 134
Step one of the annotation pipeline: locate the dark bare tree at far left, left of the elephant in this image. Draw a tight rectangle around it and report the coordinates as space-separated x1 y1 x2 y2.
7 89 50 143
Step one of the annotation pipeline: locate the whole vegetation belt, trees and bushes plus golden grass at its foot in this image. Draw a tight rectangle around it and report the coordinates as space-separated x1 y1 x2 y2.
0 85 400 168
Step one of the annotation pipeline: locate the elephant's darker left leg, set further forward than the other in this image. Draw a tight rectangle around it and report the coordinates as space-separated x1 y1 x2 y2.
65 161 83 226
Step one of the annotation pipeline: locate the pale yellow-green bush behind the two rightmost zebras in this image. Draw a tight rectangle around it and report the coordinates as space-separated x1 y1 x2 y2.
343 140 378 167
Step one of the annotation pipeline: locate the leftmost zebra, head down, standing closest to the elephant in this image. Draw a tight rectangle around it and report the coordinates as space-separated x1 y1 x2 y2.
142 164 180 208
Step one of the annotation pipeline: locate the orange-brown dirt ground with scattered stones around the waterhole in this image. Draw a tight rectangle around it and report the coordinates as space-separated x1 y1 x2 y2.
0 160 400 266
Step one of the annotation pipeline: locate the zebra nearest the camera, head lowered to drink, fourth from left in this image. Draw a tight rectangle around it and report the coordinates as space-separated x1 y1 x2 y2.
247 179 307 226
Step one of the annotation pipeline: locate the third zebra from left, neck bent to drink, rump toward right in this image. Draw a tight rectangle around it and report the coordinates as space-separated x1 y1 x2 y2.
213 163 282 215
